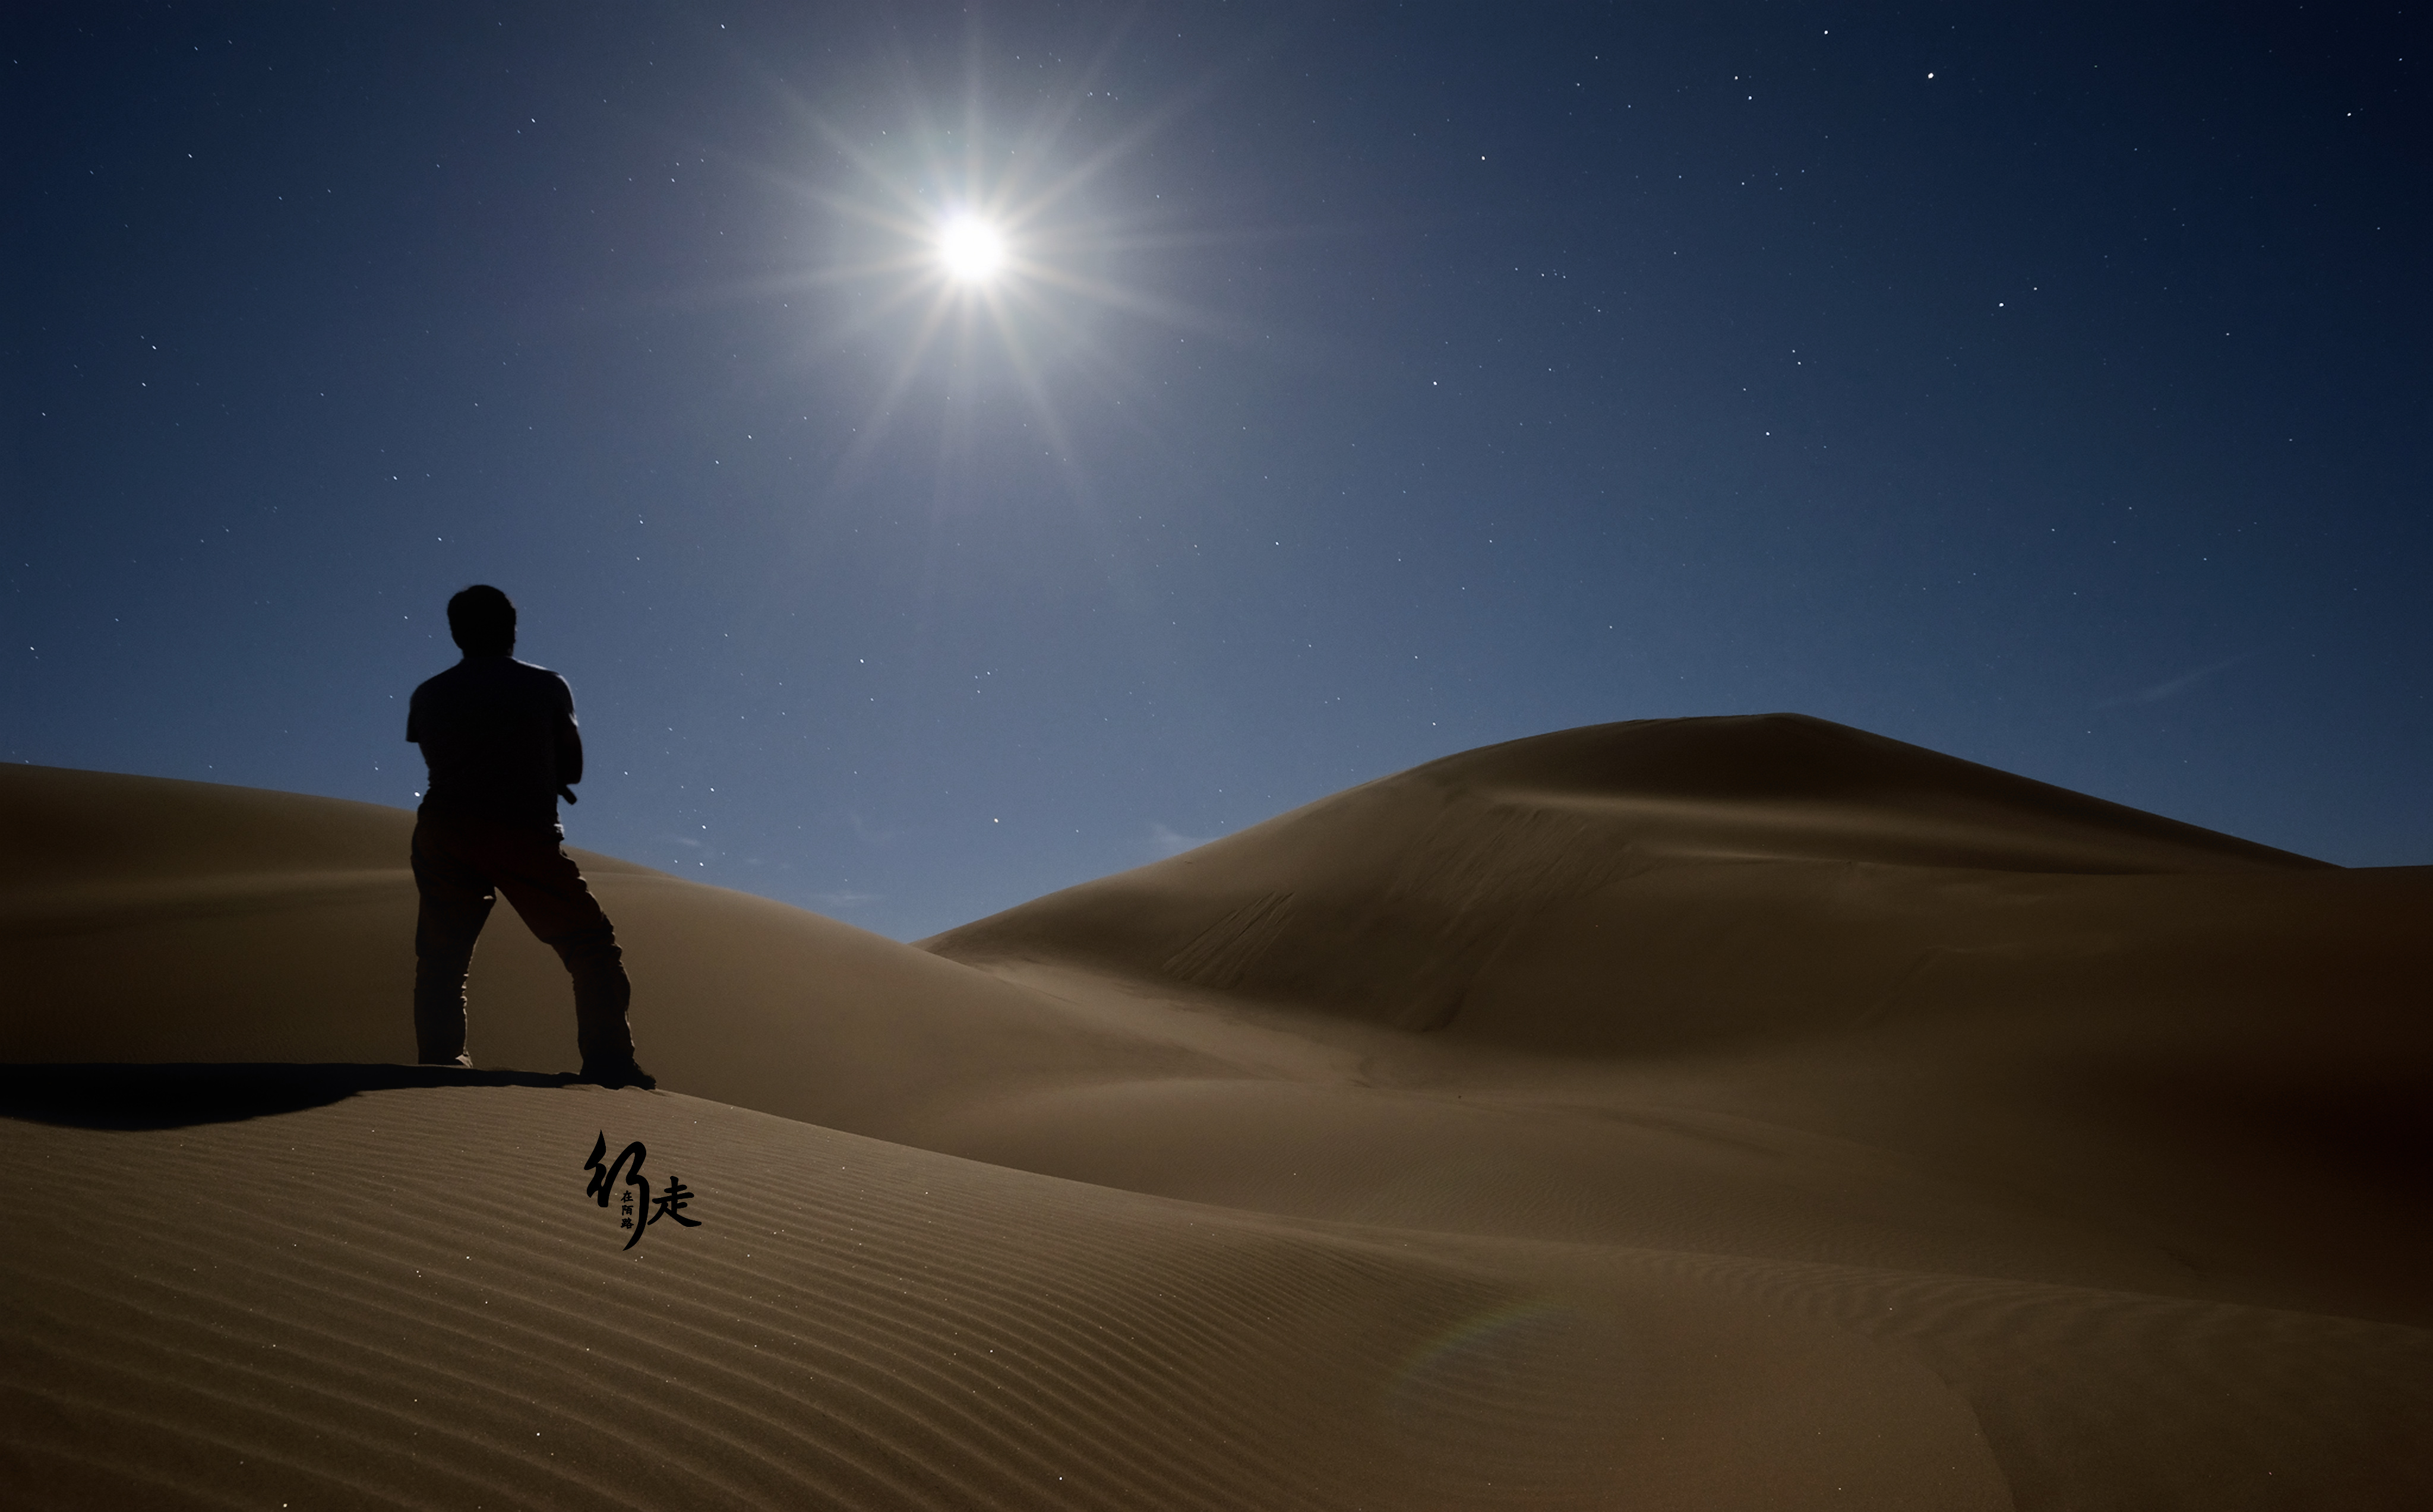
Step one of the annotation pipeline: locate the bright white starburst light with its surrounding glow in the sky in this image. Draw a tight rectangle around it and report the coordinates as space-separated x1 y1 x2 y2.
754 61 1241 494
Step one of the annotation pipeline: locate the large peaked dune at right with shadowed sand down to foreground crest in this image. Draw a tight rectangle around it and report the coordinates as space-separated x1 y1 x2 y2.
922 714 2433 1320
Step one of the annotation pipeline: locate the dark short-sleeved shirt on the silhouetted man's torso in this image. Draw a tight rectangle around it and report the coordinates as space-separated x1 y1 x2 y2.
406 656 584 829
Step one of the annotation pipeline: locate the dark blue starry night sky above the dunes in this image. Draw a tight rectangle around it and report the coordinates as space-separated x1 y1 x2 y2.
0 2 2433 938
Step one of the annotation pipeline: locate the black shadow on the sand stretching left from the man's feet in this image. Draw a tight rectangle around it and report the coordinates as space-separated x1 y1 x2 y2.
0 1062 577 1128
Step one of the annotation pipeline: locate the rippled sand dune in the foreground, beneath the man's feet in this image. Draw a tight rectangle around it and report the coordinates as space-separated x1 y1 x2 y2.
7 1087 2002 1507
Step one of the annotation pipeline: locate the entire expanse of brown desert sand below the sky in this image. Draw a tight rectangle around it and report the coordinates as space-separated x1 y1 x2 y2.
0 714 2433 1512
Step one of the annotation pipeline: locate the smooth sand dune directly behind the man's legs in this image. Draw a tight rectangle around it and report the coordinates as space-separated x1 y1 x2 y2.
0 766 1216 1128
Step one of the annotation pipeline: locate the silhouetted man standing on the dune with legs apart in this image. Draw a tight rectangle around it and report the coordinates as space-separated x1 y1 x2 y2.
406 583 657 1087
